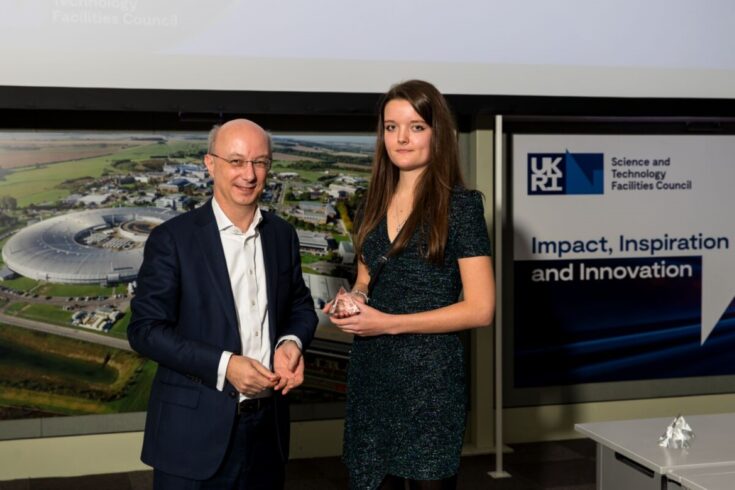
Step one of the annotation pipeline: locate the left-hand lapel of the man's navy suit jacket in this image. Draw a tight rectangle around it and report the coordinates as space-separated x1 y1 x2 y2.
195 201 240 338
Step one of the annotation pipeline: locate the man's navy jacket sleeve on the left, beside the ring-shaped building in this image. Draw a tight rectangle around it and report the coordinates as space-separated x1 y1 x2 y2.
128 225 223 387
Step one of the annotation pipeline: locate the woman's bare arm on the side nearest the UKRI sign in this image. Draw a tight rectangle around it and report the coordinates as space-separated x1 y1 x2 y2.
332 256 495 337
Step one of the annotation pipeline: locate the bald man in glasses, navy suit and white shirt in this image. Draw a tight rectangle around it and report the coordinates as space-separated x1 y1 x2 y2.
128 119 317 490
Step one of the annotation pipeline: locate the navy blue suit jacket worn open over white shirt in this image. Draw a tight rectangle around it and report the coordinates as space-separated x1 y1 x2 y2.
128 201 317 479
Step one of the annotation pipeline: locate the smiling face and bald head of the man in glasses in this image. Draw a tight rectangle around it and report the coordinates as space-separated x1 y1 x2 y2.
204 120 270 214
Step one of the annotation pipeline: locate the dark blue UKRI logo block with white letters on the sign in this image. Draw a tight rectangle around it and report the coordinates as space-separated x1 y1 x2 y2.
528 150 605 194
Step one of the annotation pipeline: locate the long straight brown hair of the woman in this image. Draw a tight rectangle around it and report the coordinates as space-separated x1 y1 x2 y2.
355 80 464 263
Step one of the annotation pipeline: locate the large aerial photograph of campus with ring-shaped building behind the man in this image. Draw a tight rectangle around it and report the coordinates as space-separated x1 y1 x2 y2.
0 131 375 420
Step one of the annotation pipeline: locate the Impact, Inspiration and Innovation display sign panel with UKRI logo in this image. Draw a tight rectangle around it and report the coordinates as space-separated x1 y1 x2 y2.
512 135 735 388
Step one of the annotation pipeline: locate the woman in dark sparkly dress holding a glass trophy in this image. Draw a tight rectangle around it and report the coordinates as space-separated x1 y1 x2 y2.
324 80 495 489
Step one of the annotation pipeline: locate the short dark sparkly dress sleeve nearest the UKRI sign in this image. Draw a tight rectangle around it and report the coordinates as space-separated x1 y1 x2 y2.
449 189 491 258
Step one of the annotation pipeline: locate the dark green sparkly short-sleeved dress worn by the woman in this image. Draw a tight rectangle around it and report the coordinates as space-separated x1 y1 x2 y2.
343 189 490 490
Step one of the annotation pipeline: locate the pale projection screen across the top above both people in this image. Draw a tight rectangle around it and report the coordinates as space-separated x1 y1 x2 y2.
0 0 735 98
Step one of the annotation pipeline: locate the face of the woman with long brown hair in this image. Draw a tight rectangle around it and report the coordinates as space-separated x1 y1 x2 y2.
383 99 431 170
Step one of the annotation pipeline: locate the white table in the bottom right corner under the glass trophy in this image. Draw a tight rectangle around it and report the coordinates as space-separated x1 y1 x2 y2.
574 413 735 490
